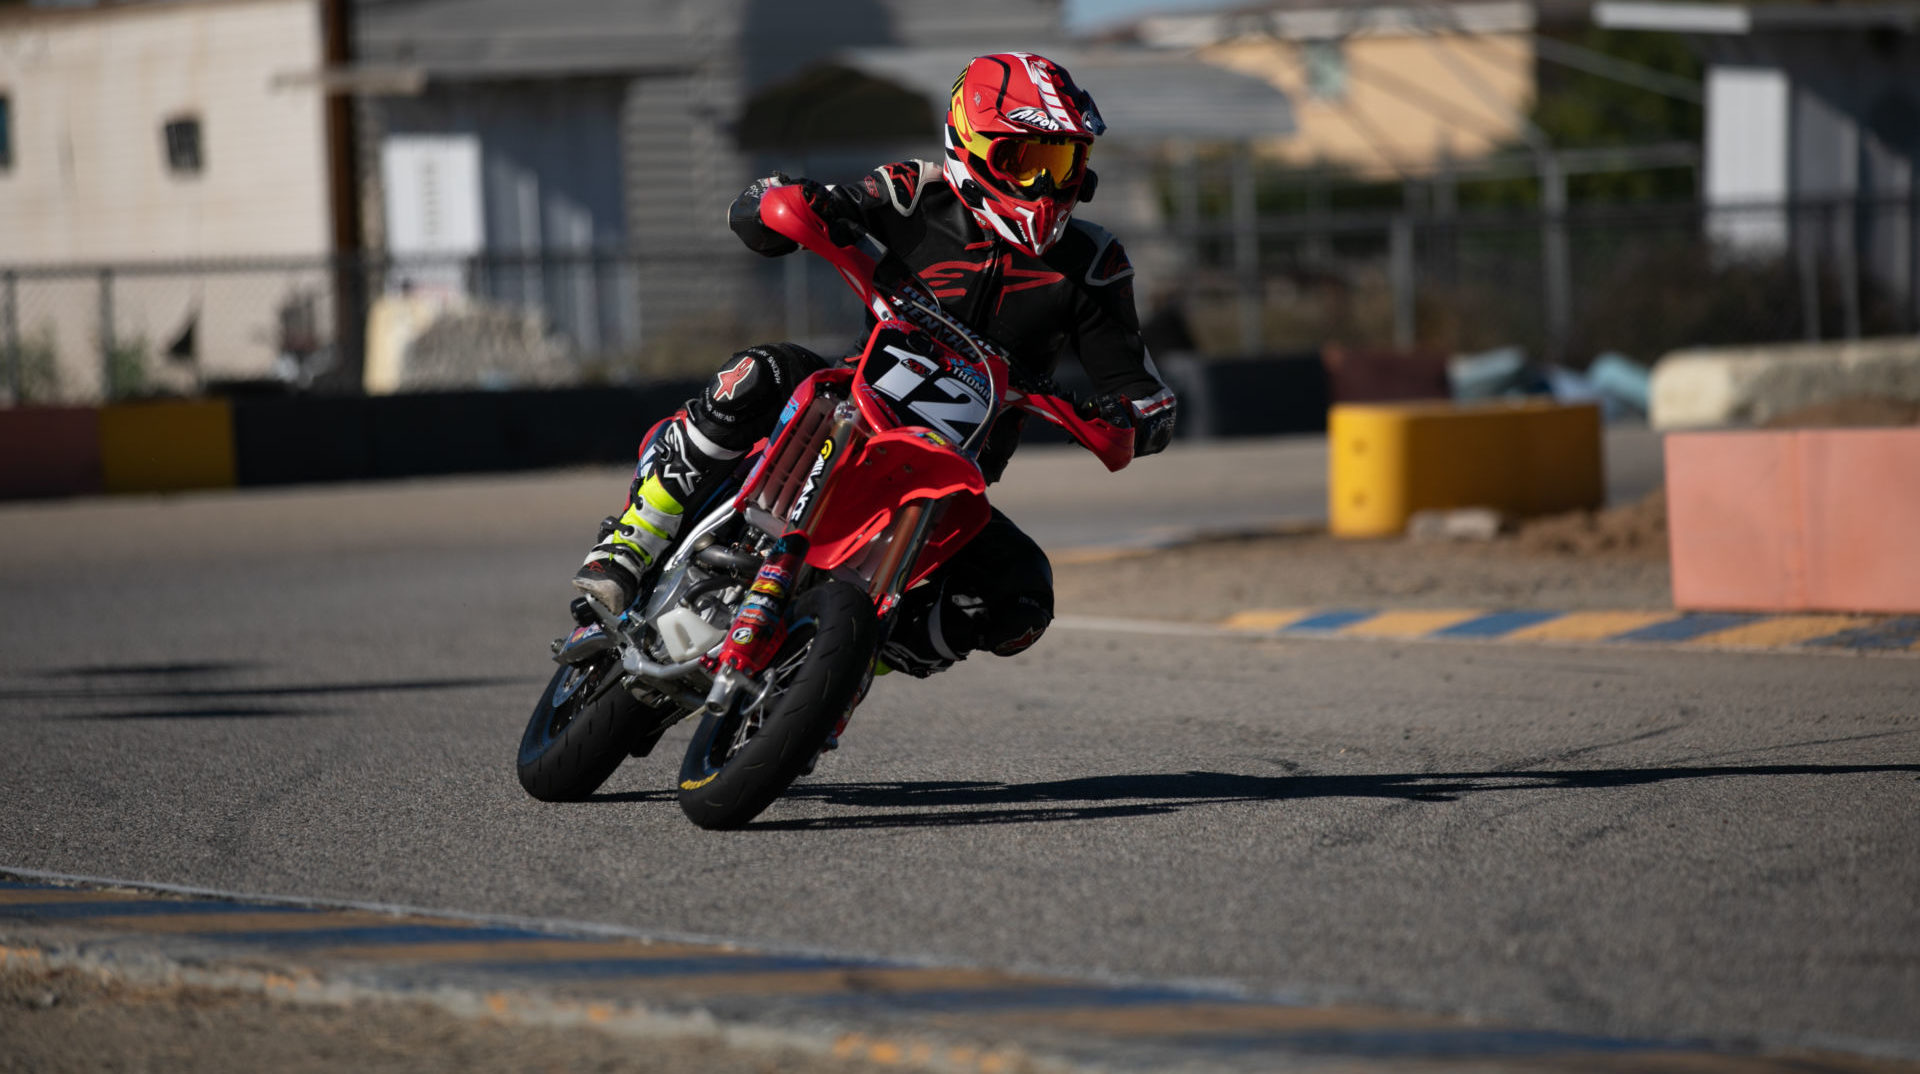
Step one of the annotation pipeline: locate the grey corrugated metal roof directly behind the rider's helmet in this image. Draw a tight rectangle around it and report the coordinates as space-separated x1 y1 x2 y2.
837 48 1294 140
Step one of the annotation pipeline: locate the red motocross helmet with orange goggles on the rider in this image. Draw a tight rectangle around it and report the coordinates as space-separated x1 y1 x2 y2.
947 52 1106 257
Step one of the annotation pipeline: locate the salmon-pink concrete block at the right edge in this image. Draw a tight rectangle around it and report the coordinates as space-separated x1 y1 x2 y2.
1667 428 1920 613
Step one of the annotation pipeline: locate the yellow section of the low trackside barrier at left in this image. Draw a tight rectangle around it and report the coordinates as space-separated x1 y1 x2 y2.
100 400 234 492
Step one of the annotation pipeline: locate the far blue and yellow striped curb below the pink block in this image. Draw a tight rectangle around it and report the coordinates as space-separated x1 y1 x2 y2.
1221 607 1920 653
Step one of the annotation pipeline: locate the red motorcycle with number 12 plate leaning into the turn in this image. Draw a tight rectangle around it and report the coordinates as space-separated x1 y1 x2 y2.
518 186 1133 828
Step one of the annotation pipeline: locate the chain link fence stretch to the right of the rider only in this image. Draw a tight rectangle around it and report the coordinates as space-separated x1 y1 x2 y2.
1142 200 1920 367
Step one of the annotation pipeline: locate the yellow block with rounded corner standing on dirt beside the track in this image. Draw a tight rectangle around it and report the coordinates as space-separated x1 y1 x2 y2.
1327 402 1605 536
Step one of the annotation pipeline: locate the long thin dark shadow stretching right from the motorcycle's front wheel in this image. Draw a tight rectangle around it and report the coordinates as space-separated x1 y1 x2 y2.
729 756 1920 832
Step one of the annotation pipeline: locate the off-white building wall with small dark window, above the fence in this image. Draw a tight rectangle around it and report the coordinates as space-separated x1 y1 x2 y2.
0 0 328 263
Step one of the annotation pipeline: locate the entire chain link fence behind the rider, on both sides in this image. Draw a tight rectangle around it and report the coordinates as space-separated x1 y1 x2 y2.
0 200 1920 403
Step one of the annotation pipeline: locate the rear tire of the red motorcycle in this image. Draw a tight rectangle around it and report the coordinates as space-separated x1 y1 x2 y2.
516 653 674 801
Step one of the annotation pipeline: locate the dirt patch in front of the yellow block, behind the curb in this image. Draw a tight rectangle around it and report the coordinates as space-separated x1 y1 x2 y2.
1054 492 1672 622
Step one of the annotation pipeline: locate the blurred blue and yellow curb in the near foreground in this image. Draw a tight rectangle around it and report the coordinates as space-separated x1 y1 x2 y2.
0 878 1920 1074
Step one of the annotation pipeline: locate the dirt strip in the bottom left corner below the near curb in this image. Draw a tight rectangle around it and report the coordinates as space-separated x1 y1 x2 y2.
0 964 913 1074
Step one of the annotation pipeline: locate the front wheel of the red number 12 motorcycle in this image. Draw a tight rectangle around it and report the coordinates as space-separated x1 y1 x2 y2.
680 582 879 830
